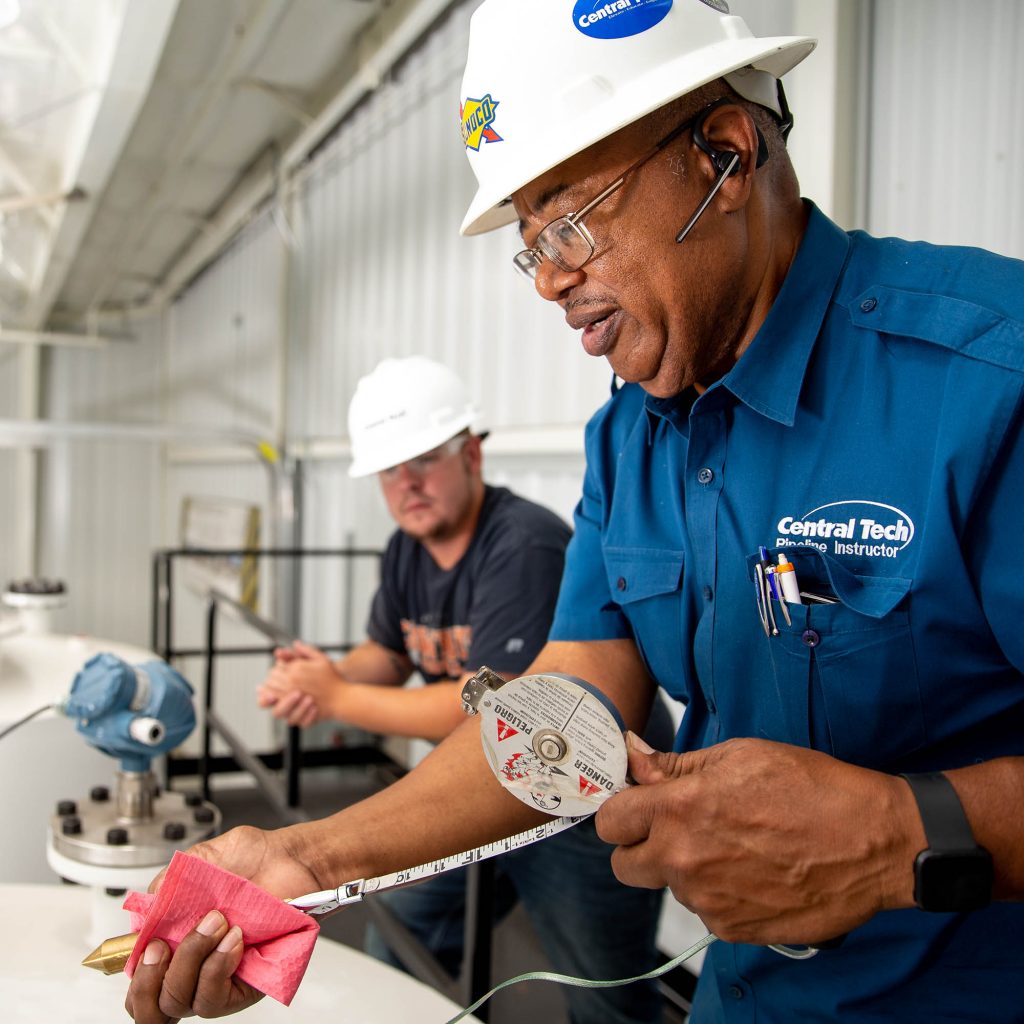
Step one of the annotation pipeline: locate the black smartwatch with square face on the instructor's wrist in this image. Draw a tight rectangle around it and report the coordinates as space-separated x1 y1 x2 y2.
903 772 993 912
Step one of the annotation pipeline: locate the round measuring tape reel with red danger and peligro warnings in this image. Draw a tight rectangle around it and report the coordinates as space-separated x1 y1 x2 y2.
462 668 627 815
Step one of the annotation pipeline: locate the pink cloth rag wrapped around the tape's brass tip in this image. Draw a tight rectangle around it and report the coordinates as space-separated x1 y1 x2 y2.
124 853 319 1007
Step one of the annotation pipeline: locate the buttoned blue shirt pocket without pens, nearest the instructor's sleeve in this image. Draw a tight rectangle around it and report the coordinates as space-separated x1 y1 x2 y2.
604 548 684 695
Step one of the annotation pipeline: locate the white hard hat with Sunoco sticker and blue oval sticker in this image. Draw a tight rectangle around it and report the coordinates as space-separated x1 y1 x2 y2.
460 0 816 234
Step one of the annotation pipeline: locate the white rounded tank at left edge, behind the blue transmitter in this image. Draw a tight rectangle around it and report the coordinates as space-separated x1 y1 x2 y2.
0 633 157 883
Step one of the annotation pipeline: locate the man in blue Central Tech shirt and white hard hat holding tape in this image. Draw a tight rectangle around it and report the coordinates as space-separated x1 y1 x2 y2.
123 0 1024 1024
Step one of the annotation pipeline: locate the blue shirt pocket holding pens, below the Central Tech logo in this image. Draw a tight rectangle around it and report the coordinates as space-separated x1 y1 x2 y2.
749 549 926 768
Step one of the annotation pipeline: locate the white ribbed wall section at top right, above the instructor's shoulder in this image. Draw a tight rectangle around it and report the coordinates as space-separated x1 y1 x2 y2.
867 0 1024 258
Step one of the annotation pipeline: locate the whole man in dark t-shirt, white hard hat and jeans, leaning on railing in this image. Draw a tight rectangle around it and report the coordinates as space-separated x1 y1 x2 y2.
258 356 671 1024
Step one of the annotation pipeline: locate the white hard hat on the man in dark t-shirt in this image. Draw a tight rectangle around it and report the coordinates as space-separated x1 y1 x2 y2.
348 355 479 476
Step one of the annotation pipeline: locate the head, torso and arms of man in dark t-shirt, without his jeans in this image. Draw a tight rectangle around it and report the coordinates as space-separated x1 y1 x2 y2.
259 356 571 740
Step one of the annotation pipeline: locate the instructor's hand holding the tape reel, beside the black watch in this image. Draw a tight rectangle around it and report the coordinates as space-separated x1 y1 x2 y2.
596 734 925 944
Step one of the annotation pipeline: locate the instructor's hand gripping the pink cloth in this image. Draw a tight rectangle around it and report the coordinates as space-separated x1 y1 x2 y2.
125 827 322 1024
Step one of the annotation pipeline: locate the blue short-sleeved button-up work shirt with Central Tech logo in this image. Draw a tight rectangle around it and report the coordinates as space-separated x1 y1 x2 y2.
551 201 1024 1024
